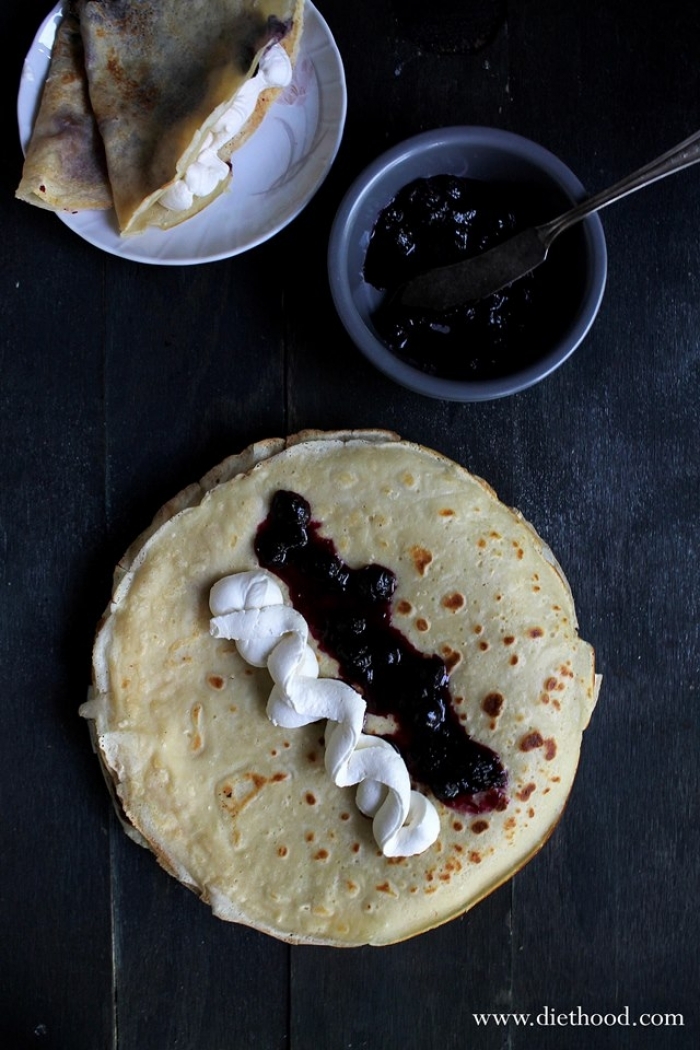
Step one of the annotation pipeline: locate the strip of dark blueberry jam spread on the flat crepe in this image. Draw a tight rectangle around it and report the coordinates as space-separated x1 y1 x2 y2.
255 490 506 813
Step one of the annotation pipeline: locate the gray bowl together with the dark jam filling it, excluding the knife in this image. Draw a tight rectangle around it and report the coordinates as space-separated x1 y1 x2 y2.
328 127 607 401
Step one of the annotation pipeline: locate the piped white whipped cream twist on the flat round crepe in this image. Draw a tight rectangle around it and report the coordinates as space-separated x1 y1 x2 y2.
209 569 440 857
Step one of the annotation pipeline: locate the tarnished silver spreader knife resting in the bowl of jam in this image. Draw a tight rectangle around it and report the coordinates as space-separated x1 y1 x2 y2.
395 125 700 311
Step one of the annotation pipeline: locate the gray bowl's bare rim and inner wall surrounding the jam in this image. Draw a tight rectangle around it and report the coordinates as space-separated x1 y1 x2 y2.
327 127 608 401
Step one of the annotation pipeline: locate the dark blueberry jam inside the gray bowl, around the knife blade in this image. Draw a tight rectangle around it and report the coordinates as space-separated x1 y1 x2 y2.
363 175 584 379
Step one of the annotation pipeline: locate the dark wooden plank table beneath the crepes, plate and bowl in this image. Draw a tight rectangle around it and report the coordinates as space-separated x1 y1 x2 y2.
0 0 700 1050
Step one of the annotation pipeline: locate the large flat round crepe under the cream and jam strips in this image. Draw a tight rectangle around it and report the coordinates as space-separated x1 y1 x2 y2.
81 432 598 946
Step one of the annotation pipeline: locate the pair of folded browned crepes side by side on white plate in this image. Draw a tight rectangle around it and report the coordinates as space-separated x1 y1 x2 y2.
17 0 303 233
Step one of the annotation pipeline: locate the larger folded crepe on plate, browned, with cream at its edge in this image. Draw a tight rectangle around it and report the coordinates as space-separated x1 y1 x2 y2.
79 0 303 233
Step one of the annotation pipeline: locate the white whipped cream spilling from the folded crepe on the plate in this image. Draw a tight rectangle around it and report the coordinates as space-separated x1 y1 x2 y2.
158 44 292 211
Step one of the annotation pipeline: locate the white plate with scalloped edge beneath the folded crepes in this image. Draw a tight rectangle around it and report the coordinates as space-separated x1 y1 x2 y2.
17 0 347 266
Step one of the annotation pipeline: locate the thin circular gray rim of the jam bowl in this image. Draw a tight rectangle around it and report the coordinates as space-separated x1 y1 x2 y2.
327 124 608 401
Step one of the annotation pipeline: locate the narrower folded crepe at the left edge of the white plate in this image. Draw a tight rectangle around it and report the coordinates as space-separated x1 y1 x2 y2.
16 13 112 211
